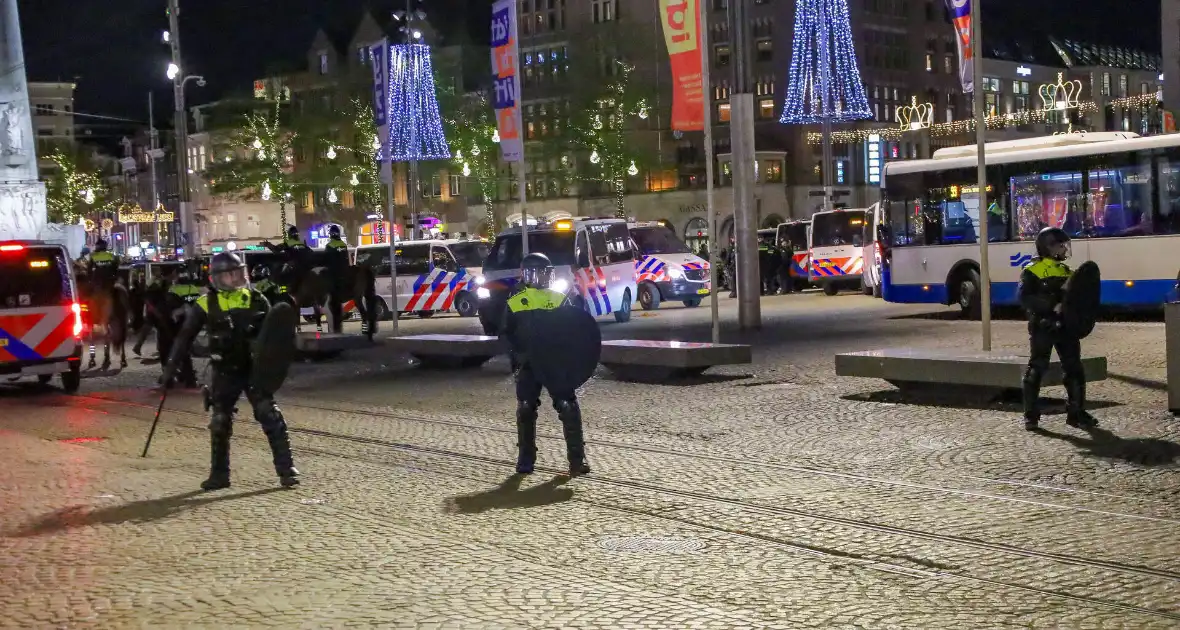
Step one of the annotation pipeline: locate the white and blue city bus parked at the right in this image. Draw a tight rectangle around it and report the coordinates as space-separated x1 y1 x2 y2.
872 133 1180 317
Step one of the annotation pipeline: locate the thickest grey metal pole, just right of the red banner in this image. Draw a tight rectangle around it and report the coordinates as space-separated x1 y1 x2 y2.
729 0 762 330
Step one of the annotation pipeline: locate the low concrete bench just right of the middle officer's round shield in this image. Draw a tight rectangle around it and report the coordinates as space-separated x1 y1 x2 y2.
598 340 753 381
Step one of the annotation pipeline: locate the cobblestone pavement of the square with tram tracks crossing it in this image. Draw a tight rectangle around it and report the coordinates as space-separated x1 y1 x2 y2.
0 295 1180 629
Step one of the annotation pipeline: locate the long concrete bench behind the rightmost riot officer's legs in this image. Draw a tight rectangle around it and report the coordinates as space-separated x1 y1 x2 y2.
835 348 1107 396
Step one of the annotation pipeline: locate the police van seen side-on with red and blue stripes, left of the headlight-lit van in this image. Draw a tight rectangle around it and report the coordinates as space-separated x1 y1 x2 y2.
356 238 487 320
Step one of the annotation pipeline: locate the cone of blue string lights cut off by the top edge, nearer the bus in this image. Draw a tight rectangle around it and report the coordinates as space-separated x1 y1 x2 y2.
779 0 872 124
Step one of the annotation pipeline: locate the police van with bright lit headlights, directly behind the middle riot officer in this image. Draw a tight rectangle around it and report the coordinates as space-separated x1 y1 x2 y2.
477 218 638 335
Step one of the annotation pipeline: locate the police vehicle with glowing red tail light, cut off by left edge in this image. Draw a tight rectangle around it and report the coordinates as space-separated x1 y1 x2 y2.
0 241 84 393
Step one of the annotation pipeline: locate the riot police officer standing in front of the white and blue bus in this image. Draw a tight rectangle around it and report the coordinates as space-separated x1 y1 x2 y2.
1020 228 1097 431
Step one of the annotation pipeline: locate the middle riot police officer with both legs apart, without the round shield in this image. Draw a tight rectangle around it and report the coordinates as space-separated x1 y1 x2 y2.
500 254 590 477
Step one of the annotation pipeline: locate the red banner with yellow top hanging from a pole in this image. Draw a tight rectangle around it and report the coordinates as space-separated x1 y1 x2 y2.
660 0 704 131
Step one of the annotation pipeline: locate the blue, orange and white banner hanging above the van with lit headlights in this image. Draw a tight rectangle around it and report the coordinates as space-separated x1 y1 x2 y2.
492 0 524 162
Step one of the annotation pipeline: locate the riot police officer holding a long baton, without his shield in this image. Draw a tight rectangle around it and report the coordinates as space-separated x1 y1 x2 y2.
163 251 299 491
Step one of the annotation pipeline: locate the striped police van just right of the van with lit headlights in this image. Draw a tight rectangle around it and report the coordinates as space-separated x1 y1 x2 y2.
629 222 712 310
